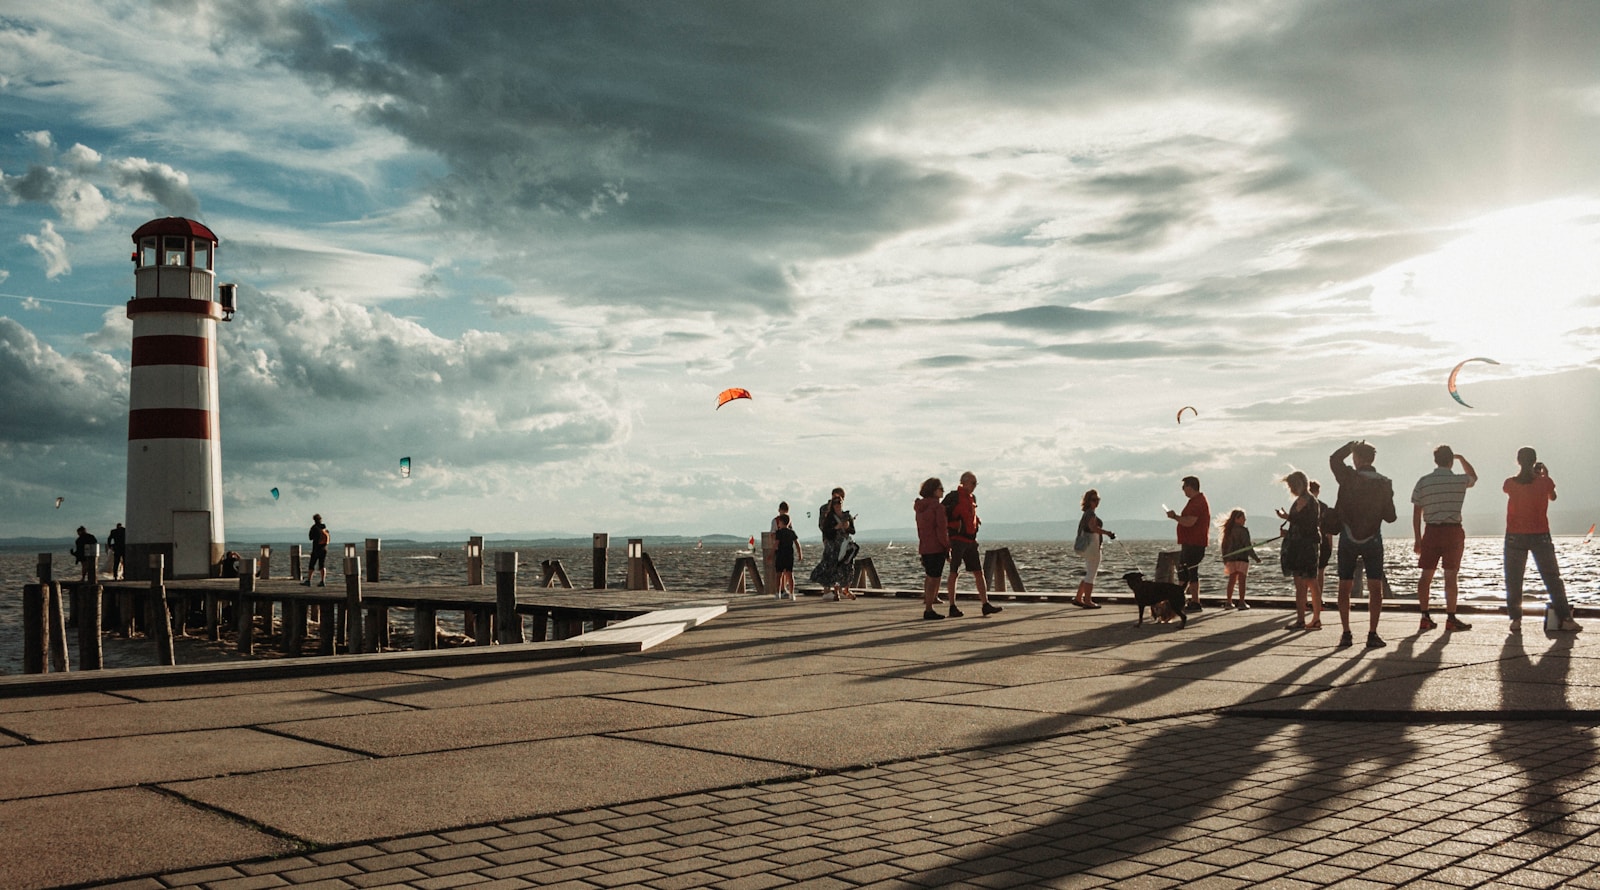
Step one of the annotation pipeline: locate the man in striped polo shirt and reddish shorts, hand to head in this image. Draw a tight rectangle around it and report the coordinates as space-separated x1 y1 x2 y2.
1411 445 1478 632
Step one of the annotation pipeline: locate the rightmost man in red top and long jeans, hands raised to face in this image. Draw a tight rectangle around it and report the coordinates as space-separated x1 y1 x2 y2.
1501 448 1582 634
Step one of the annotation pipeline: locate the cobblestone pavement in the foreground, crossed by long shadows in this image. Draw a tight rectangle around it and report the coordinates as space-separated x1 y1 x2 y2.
120 716 1600 890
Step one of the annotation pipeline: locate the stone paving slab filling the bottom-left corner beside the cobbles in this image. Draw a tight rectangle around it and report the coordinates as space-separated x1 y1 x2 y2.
0 788 293 890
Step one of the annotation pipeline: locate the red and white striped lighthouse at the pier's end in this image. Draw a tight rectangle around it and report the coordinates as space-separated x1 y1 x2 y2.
125 216 234 578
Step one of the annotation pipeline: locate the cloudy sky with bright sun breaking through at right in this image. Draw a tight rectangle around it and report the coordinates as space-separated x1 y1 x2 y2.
0 0 1600 538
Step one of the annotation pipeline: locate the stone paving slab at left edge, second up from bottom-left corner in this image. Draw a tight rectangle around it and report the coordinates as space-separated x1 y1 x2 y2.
0 728 355 800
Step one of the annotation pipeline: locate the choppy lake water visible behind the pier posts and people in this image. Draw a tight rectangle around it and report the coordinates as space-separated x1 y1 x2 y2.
0 536 1600 674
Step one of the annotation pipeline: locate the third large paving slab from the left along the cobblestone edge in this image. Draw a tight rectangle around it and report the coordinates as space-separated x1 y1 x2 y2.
621 701 1114 770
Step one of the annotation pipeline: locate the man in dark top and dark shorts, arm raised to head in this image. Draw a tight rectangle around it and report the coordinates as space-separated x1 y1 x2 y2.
1328 440 1397 648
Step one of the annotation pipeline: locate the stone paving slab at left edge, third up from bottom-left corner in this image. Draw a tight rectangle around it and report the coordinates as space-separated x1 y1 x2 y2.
0 690 400 741
